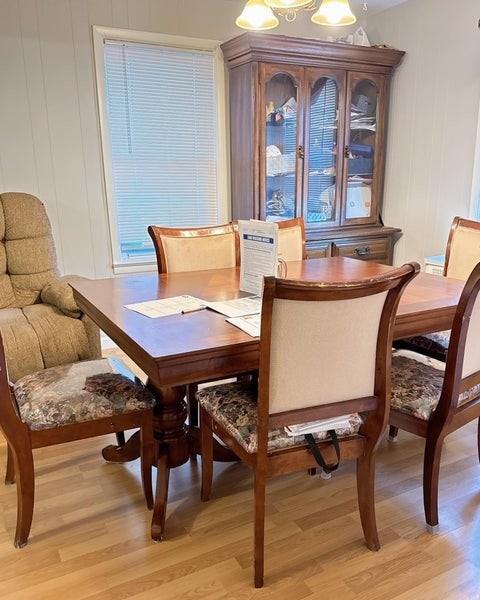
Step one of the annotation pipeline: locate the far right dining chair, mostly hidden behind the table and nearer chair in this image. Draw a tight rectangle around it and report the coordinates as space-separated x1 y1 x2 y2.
394 217 480 362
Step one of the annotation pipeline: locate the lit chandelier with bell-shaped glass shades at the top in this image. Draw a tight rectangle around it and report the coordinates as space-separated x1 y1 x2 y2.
236 0 360 31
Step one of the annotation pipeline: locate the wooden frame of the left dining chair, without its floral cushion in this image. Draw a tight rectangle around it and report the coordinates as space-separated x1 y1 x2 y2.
0 336 155 548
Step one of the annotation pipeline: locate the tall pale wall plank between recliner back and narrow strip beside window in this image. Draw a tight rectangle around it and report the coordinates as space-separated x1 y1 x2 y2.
37 0 95 275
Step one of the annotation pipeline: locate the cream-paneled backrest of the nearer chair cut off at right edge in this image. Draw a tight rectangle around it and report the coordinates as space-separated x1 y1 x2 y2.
440 262 480 419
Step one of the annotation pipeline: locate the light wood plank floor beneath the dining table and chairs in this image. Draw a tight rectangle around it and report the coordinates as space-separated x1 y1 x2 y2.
0 350 480 600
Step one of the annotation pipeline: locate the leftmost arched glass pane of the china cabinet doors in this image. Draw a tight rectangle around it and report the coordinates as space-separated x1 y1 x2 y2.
261 65 301 221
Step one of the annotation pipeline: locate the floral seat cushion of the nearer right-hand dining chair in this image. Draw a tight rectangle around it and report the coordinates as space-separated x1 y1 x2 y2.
391 350 480 421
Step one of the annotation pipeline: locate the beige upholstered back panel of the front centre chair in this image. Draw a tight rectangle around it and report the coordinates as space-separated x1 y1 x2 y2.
270 292 387 414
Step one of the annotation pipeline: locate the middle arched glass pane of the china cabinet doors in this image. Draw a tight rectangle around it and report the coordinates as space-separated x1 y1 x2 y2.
304 69 345 226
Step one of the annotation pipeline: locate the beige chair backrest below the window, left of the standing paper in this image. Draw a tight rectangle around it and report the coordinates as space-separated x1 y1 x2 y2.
148 223 239 273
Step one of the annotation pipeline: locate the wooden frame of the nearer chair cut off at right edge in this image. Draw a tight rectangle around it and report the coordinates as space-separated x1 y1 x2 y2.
389 260 480 533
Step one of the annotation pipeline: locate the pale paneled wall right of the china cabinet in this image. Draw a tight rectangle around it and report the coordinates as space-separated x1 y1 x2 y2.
368 0 480 263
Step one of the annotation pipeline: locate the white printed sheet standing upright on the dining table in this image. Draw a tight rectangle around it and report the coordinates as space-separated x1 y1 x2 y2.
238 220 278 296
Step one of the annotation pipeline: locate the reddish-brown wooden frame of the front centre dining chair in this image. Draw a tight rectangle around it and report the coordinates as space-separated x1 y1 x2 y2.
200 264 420 587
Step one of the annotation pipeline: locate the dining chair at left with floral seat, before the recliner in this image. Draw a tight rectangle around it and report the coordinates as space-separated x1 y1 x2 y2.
0 336 155 548
